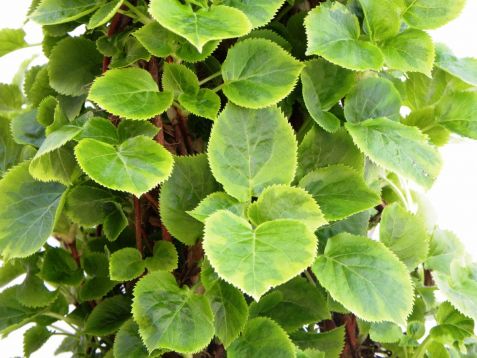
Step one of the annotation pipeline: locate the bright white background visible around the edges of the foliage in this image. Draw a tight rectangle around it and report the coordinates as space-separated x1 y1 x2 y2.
0 0 477 358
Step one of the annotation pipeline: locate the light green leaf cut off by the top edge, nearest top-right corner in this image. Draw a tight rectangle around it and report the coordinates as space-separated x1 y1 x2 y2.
403 0 465 30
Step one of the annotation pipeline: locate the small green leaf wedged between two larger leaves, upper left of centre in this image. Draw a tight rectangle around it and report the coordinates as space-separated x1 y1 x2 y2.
162 63 199 96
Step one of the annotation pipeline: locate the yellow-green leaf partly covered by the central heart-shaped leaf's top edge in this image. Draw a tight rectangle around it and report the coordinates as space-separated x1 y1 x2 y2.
247 185 327 232
